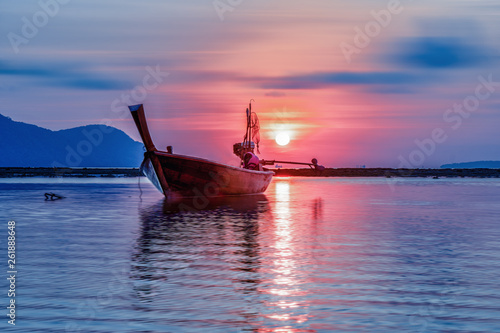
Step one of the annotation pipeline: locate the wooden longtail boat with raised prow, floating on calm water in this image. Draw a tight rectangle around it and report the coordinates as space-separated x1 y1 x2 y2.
129 104 274 197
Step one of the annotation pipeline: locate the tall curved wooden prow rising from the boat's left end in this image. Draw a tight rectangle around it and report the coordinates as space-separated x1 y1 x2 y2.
128 104 169 195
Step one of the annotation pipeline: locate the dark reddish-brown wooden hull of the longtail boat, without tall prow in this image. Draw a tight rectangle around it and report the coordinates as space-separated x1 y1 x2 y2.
141 151 274 197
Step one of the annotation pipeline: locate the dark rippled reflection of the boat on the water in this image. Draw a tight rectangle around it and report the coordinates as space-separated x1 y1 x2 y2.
131 195 269 325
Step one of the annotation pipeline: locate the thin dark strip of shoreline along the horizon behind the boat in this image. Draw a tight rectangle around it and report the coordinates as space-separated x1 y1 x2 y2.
0 167 500 178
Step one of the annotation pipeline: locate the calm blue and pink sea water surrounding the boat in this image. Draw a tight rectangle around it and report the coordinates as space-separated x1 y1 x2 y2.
0 178 500 332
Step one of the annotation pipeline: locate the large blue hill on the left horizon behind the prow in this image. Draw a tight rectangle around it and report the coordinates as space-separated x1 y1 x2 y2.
0 114 144 167
